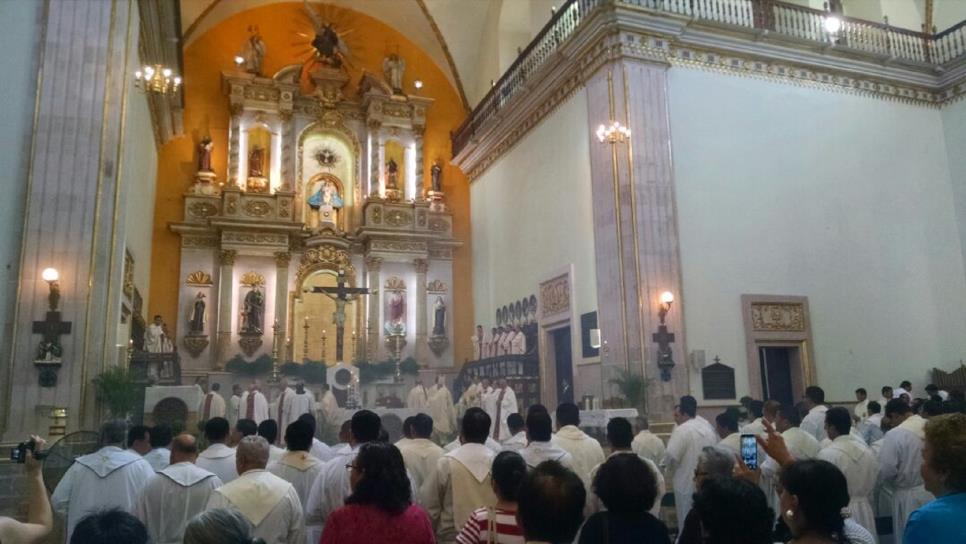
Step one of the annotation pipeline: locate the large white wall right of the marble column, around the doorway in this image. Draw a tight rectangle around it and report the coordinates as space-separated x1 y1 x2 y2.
669 68 966 400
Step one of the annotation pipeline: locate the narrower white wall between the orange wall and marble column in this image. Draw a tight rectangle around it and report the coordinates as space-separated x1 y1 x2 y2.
470 90 597 346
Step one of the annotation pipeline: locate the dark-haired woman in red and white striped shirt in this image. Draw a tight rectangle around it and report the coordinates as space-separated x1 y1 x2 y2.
456 451 527 544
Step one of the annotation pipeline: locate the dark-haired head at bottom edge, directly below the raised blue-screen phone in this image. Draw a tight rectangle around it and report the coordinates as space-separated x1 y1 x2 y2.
694 478 776 544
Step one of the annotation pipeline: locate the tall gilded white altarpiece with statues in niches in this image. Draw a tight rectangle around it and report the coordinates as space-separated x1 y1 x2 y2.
170 65 461 375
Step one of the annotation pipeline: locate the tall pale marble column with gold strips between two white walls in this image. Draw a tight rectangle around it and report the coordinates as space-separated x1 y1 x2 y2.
587 58 690 421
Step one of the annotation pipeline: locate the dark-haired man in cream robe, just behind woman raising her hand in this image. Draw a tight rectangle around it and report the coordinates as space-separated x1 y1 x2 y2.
818 407 880 535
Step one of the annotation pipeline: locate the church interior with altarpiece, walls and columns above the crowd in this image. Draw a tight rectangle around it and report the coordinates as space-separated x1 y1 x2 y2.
0 0 966 542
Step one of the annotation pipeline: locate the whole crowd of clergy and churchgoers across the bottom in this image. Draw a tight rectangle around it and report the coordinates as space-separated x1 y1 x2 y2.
0 379 966 544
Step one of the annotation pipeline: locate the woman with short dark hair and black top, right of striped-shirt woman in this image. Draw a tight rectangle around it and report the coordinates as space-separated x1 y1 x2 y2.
578 454 671 544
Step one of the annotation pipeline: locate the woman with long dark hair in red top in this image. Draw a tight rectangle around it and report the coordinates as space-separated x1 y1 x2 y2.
321 442 436 544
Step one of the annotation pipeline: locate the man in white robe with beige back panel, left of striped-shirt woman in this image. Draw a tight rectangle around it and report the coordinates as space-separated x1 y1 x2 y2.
420 408 500 544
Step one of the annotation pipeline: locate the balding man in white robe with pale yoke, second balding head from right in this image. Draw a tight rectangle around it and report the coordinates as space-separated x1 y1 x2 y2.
135 434 222 544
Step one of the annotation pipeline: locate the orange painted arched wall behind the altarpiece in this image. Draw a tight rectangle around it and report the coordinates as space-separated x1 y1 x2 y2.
147 2 474 364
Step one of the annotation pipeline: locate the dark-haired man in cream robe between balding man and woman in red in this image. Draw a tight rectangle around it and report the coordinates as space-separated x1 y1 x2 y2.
267 420 324 544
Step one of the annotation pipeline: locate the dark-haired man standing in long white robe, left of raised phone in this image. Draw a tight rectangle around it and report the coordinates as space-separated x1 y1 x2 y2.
662 395 718 520
